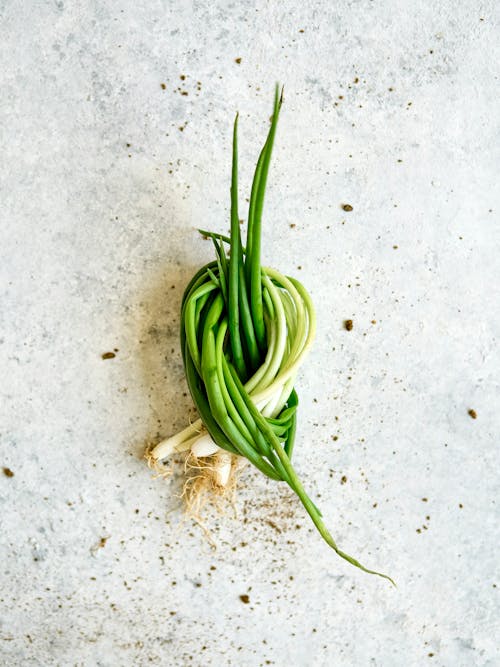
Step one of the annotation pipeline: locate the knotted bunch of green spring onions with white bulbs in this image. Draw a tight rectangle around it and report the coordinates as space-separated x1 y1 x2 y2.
148 87 392 581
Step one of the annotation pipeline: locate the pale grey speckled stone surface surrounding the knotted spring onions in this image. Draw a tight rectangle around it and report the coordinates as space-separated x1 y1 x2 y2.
0 0 500 667
